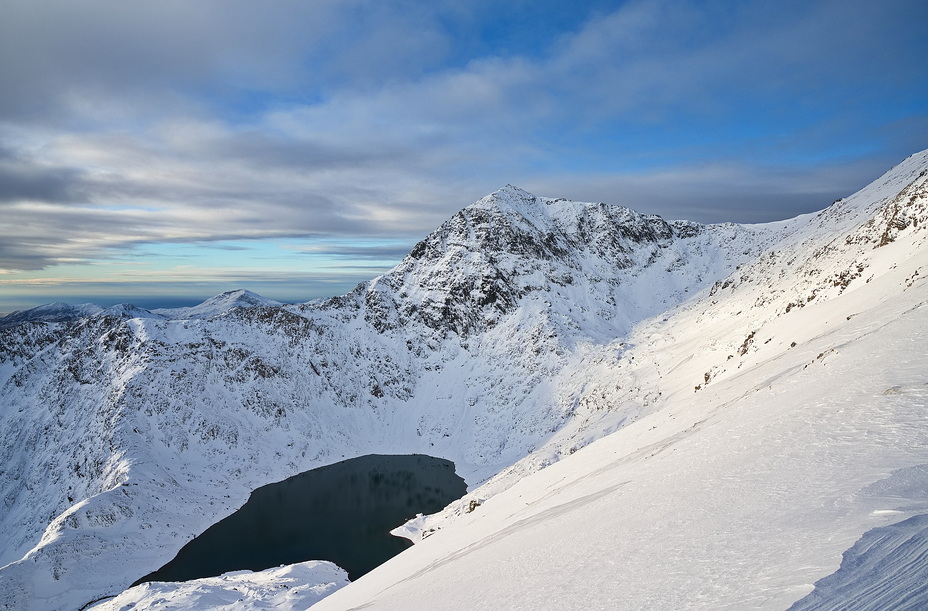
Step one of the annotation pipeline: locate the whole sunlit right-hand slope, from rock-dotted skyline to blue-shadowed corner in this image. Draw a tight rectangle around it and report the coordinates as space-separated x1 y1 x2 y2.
314 154 928 610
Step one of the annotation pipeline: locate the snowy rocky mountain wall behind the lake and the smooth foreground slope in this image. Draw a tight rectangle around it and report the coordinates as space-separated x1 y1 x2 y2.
0 153 928 609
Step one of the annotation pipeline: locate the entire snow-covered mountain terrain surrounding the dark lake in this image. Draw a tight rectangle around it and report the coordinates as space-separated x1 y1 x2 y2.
0 151 928 609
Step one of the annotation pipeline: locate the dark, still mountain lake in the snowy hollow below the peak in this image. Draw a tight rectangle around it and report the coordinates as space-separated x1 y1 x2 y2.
133 454 467 585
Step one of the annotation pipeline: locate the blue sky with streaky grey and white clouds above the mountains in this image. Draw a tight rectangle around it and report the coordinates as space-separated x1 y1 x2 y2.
0 0 928 313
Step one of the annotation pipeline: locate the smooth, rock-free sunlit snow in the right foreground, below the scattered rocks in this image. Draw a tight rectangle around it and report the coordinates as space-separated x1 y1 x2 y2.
314 274 928 610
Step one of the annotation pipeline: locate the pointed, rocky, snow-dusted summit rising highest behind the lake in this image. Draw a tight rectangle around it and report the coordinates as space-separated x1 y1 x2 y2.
366 185 772 341
